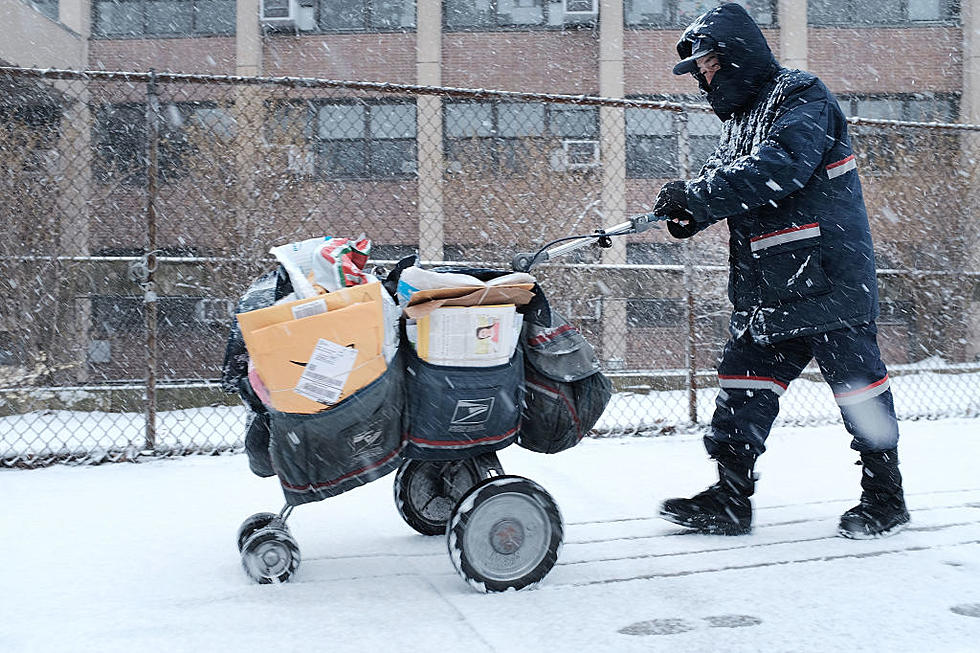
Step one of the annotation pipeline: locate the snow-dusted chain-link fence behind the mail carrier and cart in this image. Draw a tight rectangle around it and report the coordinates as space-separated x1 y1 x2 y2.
0 68 980 466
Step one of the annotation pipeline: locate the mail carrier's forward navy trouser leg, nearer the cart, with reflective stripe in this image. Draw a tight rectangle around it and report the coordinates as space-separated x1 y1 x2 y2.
704 337 810 457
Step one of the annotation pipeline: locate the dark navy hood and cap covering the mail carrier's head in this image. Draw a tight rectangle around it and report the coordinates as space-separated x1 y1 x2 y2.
674 2 779 120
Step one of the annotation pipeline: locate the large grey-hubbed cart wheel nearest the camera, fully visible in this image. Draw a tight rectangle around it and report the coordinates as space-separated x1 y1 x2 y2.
446 476 564 592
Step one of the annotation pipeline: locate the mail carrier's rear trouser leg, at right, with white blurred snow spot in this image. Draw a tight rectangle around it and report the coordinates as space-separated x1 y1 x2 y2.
813 322 898 452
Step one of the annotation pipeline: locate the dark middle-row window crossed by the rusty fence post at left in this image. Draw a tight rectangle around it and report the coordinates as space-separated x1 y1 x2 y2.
94 102 234 184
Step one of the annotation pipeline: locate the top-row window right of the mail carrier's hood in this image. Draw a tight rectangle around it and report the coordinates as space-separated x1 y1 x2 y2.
807 0 959 27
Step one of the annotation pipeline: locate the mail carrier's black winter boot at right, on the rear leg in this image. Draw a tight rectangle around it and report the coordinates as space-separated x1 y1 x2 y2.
838 449 910 540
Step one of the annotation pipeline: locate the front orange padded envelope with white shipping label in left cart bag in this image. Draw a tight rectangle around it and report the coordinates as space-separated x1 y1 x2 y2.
239 296 387 413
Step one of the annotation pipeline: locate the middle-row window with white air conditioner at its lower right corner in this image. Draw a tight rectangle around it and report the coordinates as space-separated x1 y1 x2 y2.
443 102 599 175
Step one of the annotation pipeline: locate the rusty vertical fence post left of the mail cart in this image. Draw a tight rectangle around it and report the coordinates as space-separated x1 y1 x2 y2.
143 69 160 451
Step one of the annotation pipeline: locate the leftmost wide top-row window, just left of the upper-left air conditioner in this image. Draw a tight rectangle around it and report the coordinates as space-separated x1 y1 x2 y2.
92 0 235 38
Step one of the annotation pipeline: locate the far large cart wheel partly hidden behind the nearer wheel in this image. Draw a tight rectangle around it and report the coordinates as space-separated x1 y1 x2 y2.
395 456 499 535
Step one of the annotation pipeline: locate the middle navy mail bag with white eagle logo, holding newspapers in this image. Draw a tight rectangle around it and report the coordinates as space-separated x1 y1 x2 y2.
404 346 524 460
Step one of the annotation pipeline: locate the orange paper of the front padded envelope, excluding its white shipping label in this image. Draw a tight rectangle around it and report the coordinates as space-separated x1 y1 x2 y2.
248 301 387 413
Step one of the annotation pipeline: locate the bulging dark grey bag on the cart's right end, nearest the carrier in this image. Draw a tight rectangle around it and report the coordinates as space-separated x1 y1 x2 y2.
517 309 612 453
